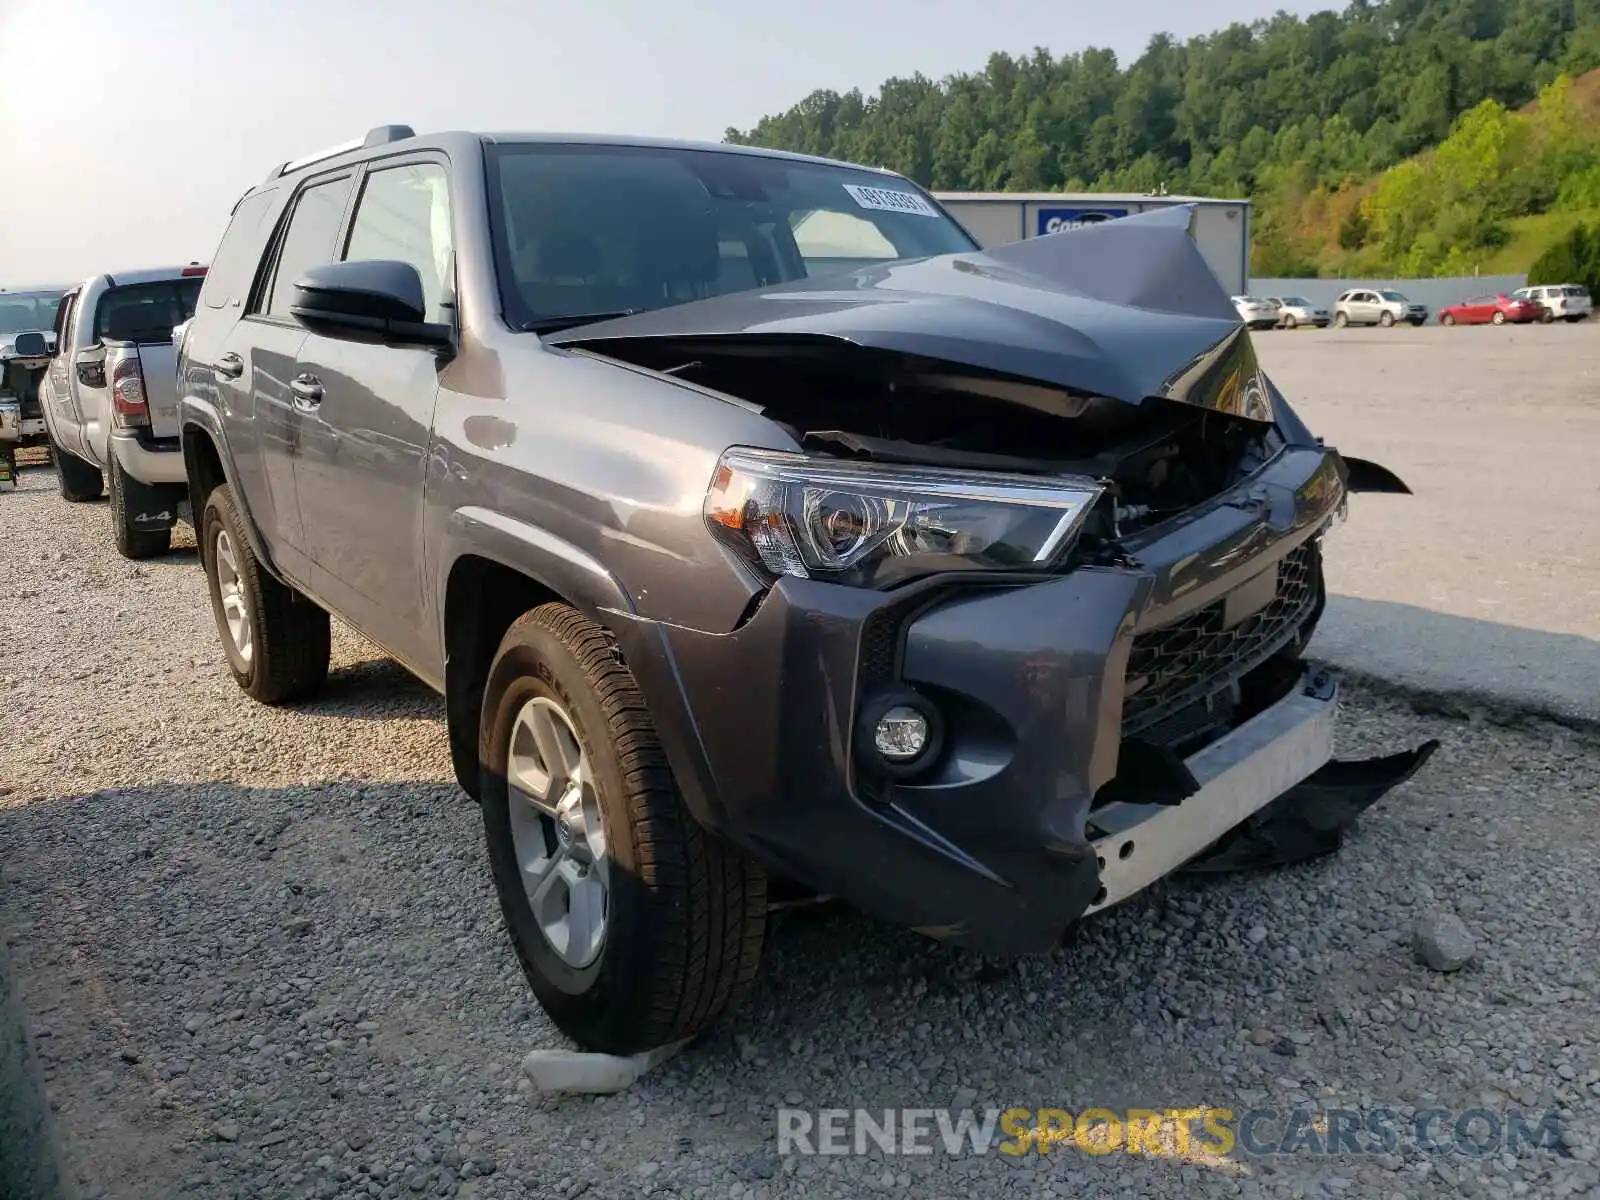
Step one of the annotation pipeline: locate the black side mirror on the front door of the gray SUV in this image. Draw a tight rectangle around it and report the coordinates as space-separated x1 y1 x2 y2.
290 259 456 350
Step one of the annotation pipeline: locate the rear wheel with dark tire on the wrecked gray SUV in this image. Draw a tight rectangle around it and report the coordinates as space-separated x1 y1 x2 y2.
200 483 331 704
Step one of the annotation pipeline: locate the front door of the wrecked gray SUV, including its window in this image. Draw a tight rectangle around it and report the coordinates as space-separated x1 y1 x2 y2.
291 158 454 662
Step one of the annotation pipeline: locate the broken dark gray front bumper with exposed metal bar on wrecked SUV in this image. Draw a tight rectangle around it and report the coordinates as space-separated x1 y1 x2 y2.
618 446 1414 952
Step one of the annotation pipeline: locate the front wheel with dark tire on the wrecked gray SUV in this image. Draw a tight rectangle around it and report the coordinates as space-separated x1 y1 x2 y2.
478 603 766 1054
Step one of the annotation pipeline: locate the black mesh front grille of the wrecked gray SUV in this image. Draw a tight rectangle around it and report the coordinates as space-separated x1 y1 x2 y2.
1122 541 1322 738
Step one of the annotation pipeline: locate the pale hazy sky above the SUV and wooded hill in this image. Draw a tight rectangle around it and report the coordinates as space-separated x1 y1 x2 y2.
0 0 1324 288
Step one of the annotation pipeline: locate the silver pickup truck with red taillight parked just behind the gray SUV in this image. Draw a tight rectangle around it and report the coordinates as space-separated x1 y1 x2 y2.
42 262 206 558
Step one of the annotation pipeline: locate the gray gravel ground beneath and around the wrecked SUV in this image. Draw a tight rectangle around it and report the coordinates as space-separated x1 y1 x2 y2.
0 331 1600 1198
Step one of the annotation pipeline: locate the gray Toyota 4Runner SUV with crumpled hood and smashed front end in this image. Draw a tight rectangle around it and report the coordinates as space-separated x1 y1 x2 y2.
179 126 1432 1053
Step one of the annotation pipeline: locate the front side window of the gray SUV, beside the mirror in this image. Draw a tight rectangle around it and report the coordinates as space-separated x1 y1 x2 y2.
344 163 456 323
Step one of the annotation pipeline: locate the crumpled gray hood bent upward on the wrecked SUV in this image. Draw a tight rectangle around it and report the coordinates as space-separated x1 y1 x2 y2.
546 205 1272 421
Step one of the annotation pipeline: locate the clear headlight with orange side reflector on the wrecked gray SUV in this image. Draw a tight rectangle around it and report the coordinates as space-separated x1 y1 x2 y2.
706 448 1104 587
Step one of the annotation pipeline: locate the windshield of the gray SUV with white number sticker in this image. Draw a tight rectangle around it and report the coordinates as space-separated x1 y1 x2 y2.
490 144 976 328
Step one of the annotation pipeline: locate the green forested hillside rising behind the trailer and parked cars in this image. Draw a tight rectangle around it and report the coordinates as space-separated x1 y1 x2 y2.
726 0 1600 275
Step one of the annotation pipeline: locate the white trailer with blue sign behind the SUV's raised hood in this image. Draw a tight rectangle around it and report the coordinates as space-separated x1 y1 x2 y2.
934 192 1250 296
